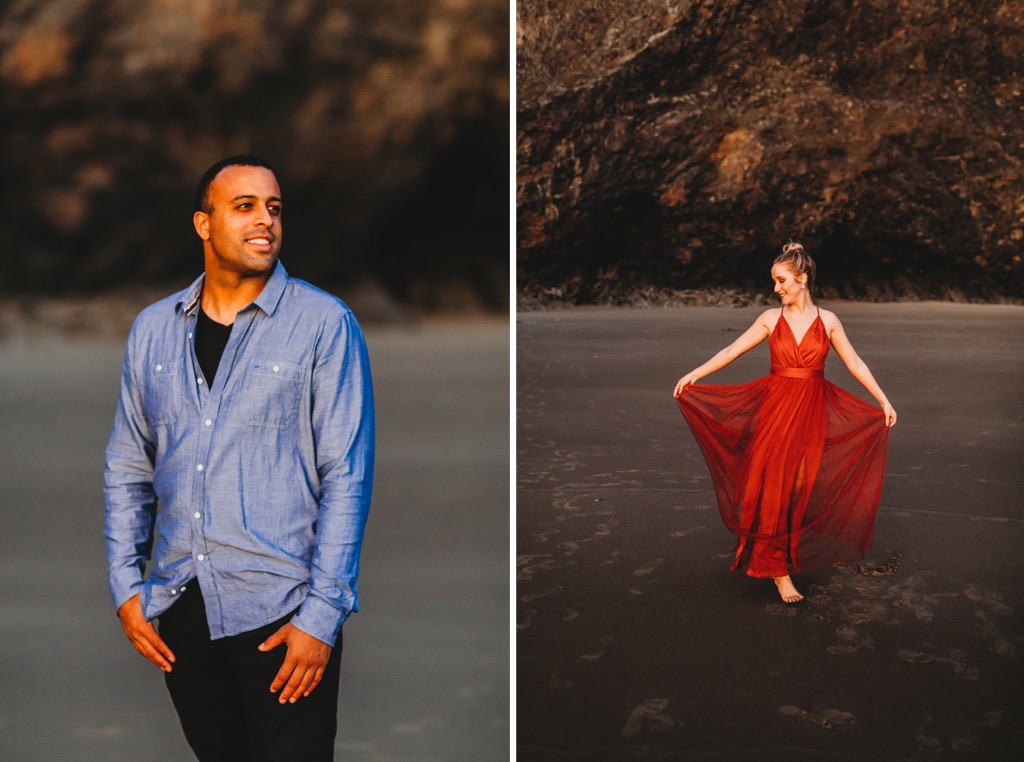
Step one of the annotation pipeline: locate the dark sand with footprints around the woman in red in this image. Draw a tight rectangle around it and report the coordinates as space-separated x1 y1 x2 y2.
516 303 1024 760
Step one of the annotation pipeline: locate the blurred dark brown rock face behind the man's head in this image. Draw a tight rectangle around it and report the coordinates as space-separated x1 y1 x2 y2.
0 0 509 307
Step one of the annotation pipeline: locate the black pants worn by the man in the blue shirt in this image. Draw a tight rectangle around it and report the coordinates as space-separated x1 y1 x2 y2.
159 580 341 762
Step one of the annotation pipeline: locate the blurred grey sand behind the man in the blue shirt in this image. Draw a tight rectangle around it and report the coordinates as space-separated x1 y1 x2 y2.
0 320 509 762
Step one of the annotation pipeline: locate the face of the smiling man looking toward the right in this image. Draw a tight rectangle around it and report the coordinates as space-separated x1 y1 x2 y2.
194 167 282 278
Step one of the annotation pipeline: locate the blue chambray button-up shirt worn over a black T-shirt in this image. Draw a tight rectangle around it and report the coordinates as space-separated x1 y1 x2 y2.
103 262 374 645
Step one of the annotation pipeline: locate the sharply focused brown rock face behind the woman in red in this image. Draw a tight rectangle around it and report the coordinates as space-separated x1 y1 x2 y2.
517 0 1024 302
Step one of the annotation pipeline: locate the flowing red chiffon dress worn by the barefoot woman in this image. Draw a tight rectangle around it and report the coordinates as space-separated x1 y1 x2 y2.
677 313 889 578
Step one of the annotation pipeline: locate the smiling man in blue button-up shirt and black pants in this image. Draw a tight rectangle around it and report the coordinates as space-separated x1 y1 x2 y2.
104 156 374 762
